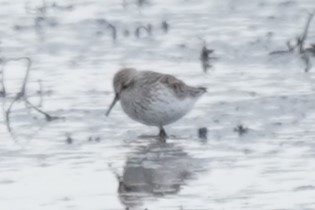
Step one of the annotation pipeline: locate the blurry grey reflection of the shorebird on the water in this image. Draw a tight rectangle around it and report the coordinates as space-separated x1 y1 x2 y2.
118 143 199 207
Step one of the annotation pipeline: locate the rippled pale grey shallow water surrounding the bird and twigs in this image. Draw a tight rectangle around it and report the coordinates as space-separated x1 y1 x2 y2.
0 0 315 210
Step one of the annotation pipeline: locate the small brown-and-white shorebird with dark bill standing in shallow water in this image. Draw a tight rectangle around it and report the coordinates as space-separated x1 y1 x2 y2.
106 68 206 142
